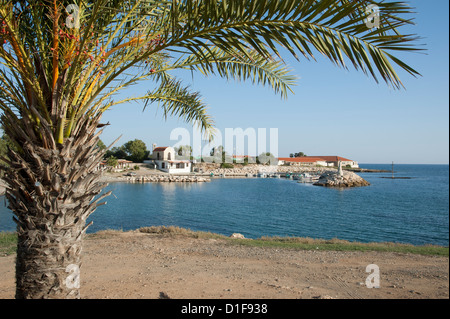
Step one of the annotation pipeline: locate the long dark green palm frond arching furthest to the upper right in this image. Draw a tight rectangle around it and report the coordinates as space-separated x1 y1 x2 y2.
163 0 419 88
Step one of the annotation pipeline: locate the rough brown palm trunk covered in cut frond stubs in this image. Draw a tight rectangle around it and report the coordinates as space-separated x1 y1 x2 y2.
2 114 109 298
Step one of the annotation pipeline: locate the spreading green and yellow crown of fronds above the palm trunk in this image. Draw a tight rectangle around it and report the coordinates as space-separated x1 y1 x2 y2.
0 0 419 143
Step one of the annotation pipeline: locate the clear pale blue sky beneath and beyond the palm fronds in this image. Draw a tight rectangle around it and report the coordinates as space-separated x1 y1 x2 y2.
102 0 449 168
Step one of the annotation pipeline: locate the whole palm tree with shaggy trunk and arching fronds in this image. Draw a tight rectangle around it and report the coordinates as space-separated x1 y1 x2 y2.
0 0 418 298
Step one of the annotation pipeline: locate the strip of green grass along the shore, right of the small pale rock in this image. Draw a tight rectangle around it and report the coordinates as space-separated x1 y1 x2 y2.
232 237 449 257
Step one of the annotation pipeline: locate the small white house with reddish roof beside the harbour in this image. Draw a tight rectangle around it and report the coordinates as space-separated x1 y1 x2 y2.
152 147 192 174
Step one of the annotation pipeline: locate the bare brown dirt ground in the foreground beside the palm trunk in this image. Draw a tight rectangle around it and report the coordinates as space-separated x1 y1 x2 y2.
0 232 449 299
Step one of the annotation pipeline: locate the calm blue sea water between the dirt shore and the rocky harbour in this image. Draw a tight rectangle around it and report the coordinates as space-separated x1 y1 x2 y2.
0 165 449 246
